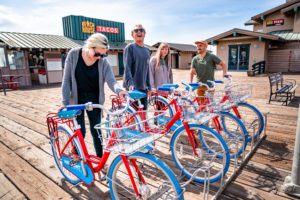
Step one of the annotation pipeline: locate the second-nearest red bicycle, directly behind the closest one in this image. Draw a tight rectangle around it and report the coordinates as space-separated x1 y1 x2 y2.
112 91 230 183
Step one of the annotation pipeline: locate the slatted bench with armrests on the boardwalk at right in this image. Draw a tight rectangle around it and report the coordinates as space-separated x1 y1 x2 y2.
268 72 298 105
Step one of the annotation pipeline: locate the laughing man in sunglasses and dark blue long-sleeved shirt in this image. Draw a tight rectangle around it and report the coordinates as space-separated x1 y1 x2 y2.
123 24 151 110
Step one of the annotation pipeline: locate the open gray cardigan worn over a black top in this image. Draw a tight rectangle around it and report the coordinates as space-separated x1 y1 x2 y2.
62 48 122 105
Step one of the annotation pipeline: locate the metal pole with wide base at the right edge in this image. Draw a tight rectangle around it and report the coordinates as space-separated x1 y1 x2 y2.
281 105 300 197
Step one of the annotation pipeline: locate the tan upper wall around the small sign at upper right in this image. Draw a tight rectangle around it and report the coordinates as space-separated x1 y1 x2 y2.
263 11 294 33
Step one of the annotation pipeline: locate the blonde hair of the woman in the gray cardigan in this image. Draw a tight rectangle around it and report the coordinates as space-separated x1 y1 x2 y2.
84 33 109 49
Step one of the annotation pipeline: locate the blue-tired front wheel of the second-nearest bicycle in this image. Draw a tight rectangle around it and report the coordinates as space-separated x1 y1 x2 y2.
170 124 230 183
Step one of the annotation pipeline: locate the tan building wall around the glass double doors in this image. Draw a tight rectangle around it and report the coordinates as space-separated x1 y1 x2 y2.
217 39 266 69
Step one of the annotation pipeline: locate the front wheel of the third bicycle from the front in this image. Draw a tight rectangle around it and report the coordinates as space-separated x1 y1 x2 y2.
217 112 248 158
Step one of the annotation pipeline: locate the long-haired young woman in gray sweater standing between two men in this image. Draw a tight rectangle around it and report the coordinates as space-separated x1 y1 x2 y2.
149 43 173 89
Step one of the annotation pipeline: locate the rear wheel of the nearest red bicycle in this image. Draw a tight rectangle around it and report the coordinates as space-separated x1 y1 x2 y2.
51 124 83 185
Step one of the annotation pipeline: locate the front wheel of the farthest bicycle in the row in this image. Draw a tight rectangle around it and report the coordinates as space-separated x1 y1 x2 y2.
231 102 265 139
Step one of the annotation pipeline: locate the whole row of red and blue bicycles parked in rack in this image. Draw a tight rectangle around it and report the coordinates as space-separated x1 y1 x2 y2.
47 77 265 199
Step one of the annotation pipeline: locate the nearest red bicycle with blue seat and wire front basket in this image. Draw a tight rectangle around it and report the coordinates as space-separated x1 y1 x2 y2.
47 92 183 199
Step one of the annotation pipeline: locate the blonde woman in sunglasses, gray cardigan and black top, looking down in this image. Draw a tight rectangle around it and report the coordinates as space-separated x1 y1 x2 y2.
62 33 127 157
